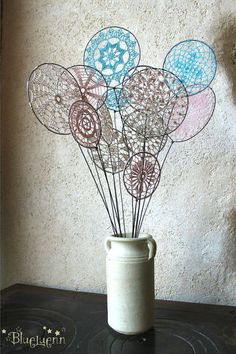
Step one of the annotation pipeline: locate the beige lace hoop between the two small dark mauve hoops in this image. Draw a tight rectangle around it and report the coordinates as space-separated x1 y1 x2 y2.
90 129 129 174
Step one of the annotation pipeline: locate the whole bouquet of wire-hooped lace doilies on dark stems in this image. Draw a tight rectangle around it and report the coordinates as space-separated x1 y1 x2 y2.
28 27 216 237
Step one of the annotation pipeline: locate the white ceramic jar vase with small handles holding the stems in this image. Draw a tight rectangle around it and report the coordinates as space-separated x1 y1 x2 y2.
105 234 156 335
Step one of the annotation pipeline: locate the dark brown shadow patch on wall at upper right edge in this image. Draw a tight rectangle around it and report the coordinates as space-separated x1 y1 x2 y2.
215 15 236 104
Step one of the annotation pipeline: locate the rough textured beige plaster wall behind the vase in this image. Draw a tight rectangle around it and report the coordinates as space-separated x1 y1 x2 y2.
2 0 236 305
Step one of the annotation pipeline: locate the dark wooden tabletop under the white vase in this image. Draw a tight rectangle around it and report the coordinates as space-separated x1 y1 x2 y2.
1 284 236 354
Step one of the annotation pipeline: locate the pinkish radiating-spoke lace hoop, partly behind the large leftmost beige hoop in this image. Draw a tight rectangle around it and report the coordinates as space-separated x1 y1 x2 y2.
68 65 107 109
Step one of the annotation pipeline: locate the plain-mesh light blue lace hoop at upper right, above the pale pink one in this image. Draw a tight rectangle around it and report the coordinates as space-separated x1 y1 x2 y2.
163 40 217 95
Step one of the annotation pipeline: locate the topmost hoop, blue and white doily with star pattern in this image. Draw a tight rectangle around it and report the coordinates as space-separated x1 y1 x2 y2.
84 27 140 87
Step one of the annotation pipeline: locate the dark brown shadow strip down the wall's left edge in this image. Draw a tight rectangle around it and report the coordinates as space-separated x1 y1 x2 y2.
1 0 30 287
